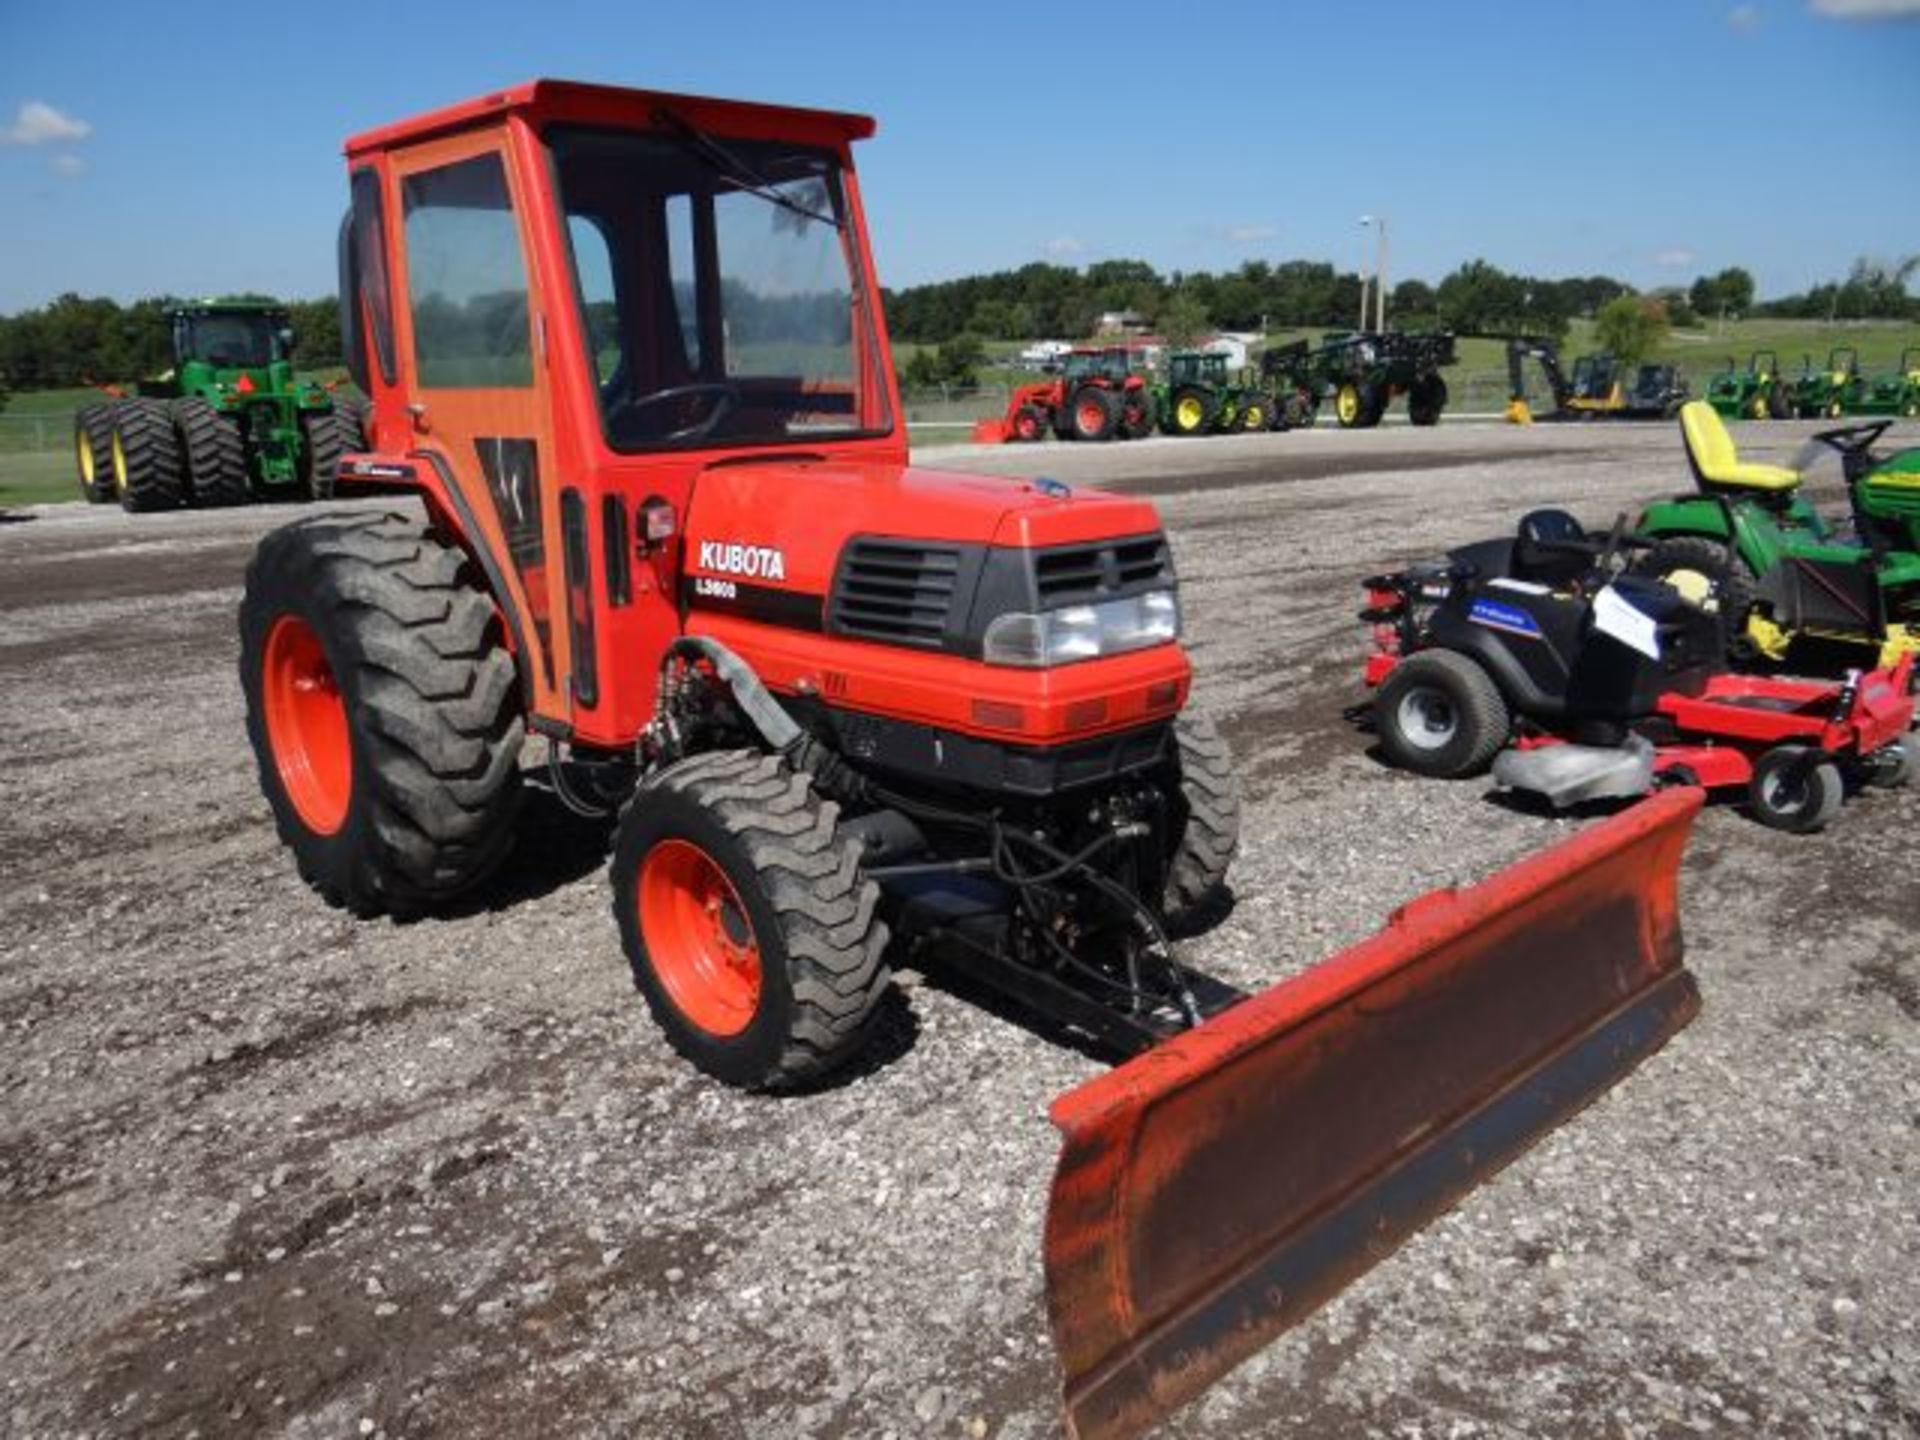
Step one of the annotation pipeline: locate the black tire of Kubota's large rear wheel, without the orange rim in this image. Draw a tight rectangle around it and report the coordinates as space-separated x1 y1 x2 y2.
240 515 526 916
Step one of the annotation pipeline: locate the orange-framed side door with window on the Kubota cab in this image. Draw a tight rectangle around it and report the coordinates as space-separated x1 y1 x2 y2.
392 129 572 728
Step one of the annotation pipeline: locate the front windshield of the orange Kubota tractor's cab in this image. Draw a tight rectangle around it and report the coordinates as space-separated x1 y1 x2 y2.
547 127 891 451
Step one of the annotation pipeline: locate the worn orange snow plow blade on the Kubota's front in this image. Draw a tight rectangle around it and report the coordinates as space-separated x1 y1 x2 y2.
1046 789 1703 1440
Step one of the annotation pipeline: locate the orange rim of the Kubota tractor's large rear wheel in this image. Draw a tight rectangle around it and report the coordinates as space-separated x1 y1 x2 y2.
261 614 353 835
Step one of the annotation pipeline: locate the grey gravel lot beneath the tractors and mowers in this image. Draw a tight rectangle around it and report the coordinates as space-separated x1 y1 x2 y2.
0 424 1920 1438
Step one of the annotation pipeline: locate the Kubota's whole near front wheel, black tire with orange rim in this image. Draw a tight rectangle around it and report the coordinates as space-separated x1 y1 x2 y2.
611 751 887 1091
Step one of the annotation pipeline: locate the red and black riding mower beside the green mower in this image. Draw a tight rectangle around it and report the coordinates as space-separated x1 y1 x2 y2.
1361 511 1914 833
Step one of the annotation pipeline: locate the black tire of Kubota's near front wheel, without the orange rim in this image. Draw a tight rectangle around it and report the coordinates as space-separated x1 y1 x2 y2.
614 751 891 1089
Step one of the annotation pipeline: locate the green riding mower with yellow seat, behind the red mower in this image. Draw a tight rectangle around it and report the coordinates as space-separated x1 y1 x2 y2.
1634 401 1920 672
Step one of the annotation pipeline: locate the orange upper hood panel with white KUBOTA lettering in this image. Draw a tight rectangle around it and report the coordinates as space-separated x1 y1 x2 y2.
685 459 1160 595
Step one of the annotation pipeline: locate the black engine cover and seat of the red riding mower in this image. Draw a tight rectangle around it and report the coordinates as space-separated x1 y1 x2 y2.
1425 568 1722 726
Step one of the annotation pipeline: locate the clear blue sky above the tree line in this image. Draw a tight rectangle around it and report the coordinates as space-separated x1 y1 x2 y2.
0 0 1920 311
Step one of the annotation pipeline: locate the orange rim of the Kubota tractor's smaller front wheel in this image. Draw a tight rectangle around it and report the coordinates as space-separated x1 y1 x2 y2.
639 839 760 1035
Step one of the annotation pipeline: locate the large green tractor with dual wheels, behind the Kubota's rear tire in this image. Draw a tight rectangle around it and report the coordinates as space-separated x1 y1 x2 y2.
73 301 363 511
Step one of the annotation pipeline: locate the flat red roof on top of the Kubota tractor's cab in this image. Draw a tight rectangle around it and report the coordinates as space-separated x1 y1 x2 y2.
346 81 876 159
